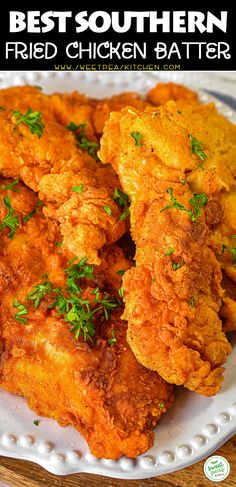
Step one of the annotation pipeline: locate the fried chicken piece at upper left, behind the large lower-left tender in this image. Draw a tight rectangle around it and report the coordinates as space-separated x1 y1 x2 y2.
0 87 128 264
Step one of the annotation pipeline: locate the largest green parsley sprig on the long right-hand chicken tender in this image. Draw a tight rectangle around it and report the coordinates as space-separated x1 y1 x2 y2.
160 188 208 222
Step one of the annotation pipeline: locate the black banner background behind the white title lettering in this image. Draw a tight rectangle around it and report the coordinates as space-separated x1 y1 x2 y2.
0 1 236 71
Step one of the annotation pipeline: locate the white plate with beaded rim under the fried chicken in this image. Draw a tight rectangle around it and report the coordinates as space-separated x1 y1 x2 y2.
0 72 236 479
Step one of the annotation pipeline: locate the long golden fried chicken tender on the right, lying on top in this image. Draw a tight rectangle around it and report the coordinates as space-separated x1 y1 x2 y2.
100 101 236 396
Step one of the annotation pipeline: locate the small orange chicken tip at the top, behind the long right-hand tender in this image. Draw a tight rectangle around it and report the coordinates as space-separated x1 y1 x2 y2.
147 83 198 106
